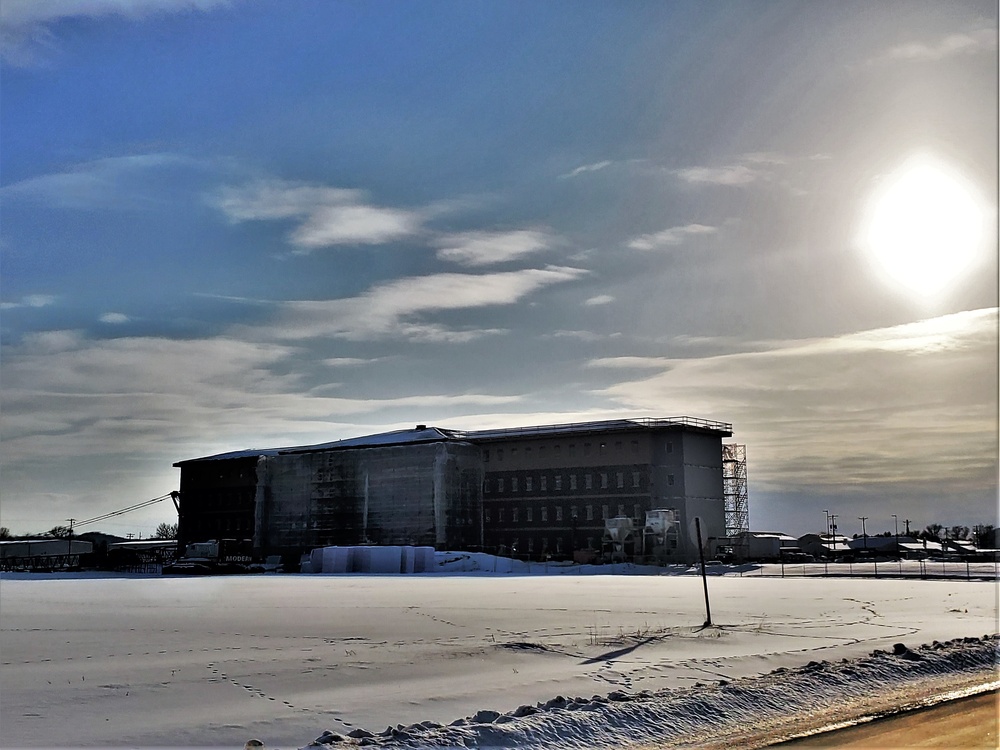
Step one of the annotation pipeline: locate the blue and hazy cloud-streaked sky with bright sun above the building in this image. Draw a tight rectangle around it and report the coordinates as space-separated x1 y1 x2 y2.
0 0 998 535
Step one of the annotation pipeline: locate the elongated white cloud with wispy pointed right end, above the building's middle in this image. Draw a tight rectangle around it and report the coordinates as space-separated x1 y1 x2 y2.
255 266 587 343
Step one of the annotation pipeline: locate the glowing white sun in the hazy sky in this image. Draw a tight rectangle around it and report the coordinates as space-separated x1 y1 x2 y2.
860 156 989 298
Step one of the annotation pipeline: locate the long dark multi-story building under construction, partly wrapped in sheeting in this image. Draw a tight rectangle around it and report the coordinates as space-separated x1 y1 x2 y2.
174 417 746 563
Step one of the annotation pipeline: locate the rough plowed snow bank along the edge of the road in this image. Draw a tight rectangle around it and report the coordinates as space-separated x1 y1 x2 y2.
300 635 1000 750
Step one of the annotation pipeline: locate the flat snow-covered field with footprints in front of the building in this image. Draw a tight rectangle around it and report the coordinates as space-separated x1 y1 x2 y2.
0 571 997 750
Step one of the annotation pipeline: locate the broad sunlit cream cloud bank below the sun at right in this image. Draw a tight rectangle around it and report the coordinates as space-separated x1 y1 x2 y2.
591 308 998 495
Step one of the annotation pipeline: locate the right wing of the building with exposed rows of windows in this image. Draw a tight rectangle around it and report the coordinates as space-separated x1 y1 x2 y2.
466 417 732 561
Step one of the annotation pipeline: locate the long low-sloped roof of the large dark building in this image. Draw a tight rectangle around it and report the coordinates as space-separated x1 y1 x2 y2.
174 417 733 466
